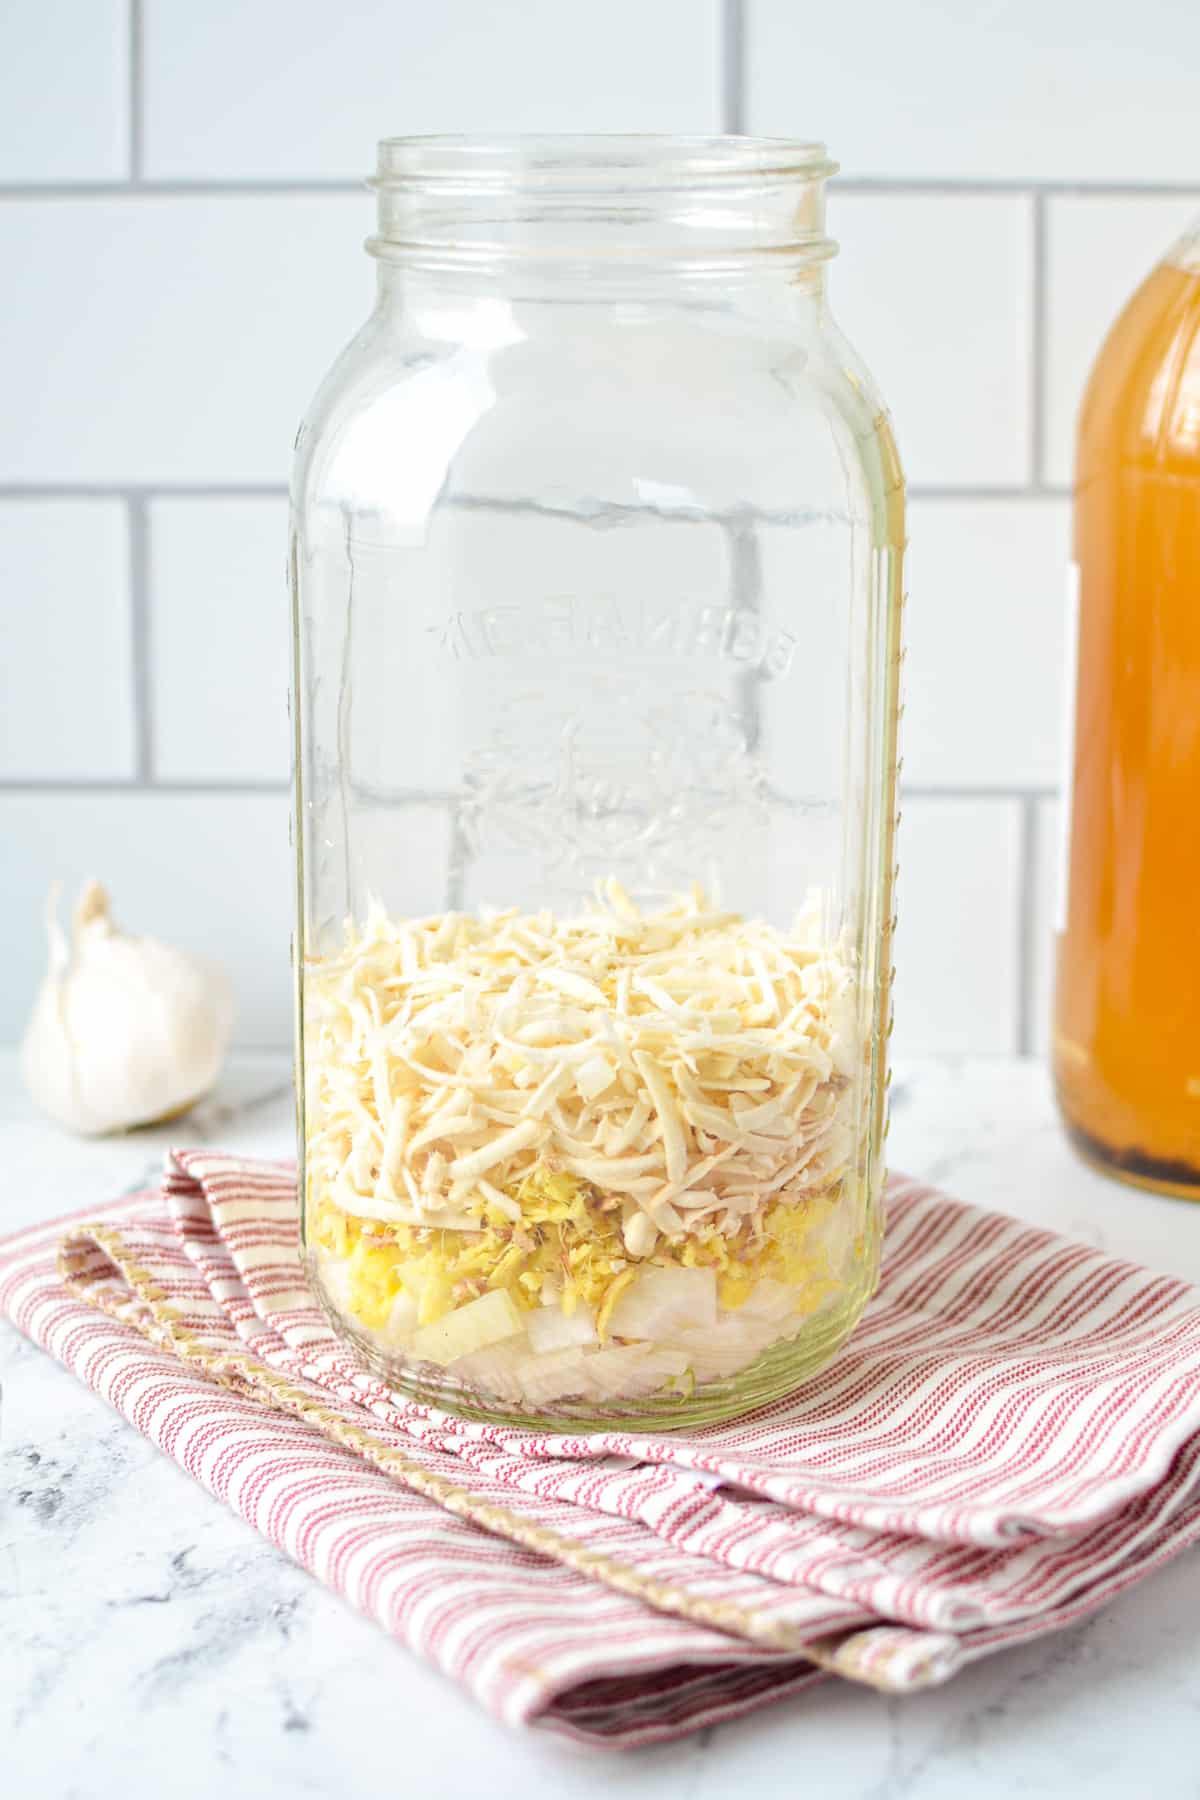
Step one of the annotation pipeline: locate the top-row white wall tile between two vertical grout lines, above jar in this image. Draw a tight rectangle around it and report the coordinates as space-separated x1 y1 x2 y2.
144 0 721 180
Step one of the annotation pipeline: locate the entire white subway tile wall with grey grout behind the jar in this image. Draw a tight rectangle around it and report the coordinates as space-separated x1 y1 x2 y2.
0 0 1200 1053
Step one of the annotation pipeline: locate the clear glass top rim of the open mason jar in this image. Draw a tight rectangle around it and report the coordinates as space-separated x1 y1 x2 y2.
367 131 838 196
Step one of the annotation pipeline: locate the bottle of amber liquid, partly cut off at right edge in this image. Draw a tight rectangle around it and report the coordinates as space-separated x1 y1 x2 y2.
1052 232 1200 1199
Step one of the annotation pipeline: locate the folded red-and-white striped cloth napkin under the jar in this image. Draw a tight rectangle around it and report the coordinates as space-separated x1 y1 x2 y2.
0 1152 1200 1746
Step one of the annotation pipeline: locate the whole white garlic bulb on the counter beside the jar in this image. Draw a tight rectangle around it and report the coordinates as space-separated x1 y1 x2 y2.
22 880 234 1134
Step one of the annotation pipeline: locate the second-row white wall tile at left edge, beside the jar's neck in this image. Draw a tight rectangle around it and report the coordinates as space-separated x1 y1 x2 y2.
0 193 372 488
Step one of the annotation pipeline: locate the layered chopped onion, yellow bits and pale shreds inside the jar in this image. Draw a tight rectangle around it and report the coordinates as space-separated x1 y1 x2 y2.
304 880 860 1406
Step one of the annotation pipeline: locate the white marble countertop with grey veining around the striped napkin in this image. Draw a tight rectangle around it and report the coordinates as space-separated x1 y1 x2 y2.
0 1057 1200 1800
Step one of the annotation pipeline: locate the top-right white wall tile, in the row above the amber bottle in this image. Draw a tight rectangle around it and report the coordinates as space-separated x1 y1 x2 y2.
747 0 1200 184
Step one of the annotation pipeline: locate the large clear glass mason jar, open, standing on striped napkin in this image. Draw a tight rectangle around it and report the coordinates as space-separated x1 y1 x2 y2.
291 139 903 1427
